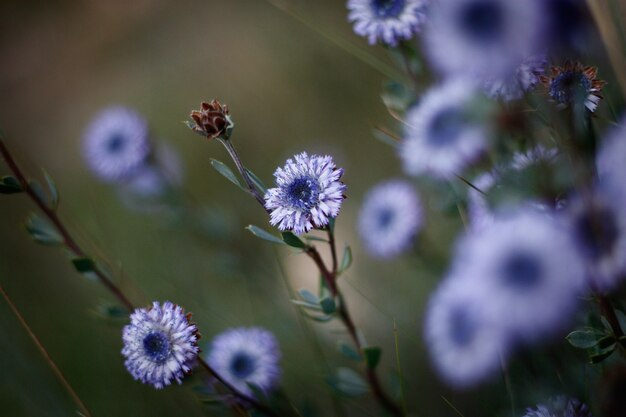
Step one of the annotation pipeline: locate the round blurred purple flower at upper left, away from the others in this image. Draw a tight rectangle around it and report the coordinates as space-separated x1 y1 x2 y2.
83 107 151 182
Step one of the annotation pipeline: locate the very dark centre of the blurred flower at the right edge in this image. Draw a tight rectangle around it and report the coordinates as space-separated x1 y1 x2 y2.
575 208 619 260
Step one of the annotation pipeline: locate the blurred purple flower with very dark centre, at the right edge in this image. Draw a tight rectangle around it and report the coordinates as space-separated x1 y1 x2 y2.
567 187 626 291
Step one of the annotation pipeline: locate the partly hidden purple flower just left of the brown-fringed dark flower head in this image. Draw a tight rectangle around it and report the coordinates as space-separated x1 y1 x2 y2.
483 54 547 101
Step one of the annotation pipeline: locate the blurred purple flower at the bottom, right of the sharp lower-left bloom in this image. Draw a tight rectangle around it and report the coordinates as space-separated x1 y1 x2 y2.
206 327 281 397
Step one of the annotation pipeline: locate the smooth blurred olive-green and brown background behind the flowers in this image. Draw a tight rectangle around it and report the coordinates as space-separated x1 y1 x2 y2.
0 0 524 417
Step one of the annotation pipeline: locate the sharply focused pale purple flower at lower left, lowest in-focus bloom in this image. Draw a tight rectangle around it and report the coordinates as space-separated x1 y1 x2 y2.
122 301 200 389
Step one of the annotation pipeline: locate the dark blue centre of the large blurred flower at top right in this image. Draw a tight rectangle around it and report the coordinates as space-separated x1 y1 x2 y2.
458 0 504 42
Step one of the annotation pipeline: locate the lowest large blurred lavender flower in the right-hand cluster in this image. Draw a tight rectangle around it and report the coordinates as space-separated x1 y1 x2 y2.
424 272 509 388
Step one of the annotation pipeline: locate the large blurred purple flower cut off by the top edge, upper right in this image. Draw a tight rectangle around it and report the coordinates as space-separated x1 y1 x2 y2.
424 0 542 79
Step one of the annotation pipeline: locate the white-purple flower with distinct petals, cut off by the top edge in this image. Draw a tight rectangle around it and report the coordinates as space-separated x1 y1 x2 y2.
347 0 428 46
